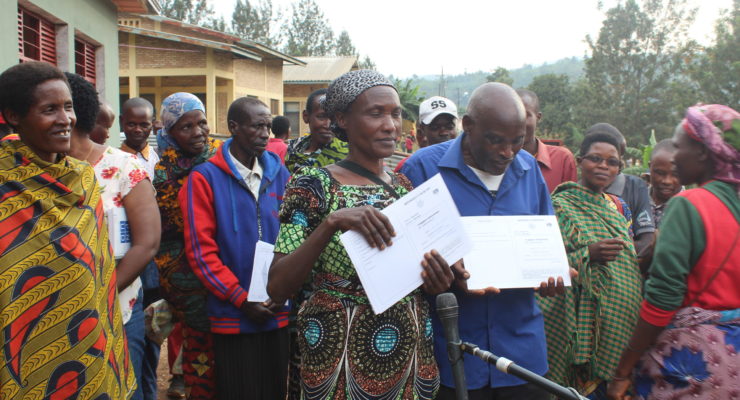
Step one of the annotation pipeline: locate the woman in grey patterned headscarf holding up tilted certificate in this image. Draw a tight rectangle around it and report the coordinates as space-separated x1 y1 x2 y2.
268 70 453 399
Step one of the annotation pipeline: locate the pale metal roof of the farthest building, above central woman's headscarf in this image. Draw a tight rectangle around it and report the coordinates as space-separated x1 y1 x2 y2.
283 56 357 83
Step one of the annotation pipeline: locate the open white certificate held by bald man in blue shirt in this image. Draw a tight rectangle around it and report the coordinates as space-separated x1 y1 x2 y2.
462 215 570 290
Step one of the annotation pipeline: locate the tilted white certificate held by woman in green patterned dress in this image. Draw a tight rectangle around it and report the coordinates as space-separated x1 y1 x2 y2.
340 174 472 314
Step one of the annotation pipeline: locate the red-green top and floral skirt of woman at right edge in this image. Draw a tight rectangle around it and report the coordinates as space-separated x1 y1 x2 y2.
633 181 740 400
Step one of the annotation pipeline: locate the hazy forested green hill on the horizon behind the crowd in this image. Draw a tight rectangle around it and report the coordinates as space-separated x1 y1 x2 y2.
404 57 584 109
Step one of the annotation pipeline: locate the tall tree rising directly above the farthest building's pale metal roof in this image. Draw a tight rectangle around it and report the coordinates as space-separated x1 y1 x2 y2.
282 0 334 56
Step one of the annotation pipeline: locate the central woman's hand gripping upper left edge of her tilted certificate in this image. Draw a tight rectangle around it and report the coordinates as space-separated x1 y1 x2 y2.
328 206 396 250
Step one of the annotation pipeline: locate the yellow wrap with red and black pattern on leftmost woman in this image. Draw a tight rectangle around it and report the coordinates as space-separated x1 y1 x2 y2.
0 140 136 400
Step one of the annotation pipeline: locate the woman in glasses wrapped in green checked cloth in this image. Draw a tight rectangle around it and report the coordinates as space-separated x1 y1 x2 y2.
540 132 641 399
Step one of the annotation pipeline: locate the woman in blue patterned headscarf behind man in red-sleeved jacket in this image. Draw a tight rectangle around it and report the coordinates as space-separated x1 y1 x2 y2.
154 93 220 399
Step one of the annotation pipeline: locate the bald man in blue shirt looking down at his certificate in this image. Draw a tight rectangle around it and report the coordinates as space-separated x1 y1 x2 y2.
401 83 563 400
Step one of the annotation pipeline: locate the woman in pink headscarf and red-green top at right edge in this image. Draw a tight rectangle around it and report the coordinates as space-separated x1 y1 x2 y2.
609 104 740 399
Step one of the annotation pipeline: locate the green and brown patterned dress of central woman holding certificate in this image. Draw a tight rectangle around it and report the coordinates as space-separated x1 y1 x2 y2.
275 168 439 399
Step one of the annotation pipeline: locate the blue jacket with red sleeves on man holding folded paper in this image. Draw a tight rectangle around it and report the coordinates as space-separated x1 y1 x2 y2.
178 140 290 334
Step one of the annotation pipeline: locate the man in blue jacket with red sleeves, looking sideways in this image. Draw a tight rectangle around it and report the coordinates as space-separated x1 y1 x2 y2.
179 97 289 400
